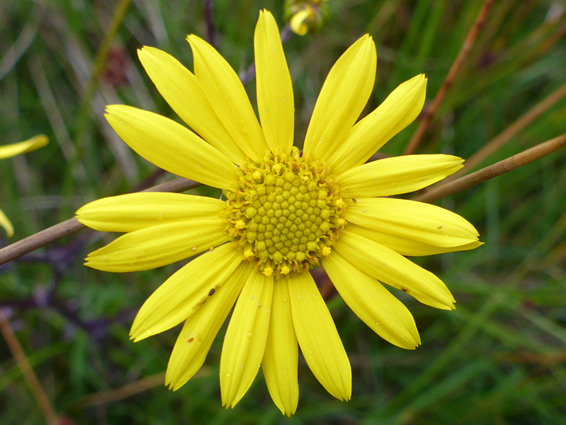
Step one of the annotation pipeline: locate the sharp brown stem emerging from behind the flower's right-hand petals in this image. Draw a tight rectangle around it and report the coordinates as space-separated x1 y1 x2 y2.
415 134 566 202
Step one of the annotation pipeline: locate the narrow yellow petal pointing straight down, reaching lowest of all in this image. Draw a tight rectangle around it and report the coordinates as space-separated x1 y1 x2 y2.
262 278 299 416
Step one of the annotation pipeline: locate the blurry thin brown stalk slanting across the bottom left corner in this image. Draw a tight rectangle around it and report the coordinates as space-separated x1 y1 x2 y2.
0 308 59 425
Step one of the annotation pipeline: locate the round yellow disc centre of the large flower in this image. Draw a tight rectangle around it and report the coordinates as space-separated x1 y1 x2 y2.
224 147 346 276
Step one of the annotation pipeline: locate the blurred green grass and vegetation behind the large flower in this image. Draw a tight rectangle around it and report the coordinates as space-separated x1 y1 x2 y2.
0 0 566 425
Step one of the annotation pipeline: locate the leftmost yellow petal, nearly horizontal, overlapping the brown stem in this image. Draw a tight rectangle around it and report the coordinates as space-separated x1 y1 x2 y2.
76 192 226 232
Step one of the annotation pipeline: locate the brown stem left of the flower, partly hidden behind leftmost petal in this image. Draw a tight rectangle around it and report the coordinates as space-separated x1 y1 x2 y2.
0 179 200 265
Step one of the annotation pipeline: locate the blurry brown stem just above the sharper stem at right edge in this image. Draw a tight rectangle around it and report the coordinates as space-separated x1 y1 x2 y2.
444 84 566 178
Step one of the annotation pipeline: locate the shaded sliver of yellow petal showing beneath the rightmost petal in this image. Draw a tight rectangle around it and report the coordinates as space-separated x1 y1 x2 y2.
348 223 483 257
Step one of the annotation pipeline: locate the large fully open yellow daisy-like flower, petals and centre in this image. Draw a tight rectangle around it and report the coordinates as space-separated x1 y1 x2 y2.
77 11 480 415
